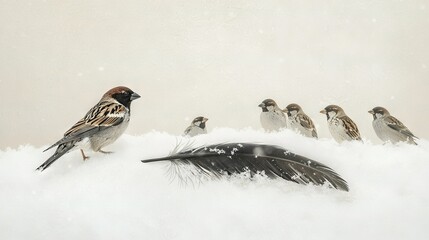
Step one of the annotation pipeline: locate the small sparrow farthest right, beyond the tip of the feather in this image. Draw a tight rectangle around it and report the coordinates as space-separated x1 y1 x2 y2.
368 107 418 145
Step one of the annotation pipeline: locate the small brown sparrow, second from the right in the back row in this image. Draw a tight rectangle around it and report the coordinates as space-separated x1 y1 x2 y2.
320 105 362 143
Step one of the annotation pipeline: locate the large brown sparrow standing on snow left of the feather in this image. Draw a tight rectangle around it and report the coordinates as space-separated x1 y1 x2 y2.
36 87 140 171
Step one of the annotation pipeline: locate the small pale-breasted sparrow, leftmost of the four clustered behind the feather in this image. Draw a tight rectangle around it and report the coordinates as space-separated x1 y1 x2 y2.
258 99 287 132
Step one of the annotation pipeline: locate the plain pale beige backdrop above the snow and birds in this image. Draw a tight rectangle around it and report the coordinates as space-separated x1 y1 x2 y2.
0 0 429 149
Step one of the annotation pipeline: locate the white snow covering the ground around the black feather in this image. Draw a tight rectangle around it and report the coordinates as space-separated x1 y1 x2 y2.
0 128 429 240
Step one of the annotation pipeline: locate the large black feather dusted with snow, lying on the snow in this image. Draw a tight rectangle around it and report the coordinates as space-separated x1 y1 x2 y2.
142 143 349 191
